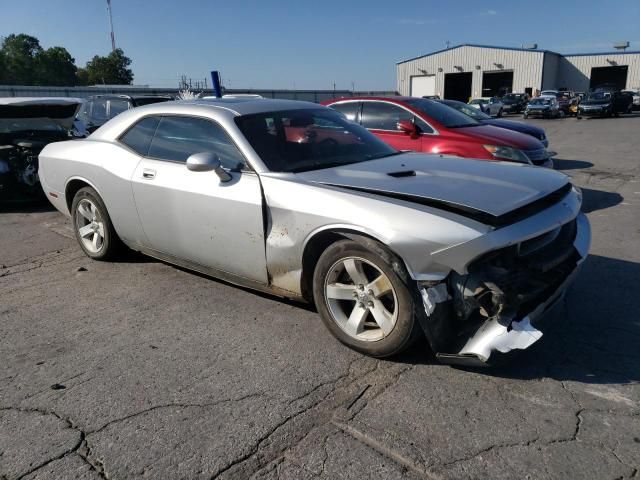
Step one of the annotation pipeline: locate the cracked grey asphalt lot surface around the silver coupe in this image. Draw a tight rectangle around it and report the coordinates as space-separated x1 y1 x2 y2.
0 116 640 480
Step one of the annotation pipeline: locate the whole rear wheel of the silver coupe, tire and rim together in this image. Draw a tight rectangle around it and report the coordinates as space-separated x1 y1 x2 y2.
71 187 120 260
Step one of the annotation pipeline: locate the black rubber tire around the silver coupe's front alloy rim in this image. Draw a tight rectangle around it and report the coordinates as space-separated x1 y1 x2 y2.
313 238 422 357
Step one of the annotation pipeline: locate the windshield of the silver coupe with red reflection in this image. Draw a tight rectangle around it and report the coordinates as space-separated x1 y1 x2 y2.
235 108 400 172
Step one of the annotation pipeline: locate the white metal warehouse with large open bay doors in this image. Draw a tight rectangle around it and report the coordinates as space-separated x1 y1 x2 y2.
397 44 640 102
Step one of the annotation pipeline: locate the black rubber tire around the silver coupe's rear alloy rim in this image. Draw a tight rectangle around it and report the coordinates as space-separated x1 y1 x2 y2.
71 187 121 260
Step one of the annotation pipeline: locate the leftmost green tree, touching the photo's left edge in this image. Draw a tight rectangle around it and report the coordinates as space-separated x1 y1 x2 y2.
2 33 42 85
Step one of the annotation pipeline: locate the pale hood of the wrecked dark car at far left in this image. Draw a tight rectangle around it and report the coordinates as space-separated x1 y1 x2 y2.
0 97 82 130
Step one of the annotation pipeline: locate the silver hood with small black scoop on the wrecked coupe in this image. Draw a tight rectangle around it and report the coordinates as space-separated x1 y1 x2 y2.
295 153 570 226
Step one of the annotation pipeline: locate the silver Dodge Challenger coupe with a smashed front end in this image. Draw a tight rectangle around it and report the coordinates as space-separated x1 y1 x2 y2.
40 98 591 364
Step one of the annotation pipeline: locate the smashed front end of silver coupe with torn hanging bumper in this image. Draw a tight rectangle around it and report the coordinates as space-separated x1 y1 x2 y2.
418 214 590 365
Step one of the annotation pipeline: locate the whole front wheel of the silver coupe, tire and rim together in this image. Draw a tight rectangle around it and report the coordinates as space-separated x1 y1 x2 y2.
313 238 421 357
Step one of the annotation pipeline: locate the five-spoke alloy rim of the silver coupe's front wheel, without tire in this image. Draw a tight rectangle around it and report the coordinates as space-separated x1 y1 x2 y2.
324 257 399 342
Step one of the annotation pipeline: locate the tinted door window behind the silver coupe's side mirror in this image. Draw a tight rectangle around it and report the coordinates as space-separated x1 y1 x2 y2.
148 116 245 169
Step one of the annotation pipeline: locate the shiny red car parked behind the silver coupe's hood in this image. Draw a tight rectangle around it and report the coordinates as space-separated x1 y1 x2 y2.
323 97 553 168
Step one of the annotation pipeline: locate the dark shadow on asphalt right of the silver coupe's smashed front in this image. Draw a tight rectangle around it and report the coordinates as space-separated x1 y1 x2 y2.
476 255 640 384
